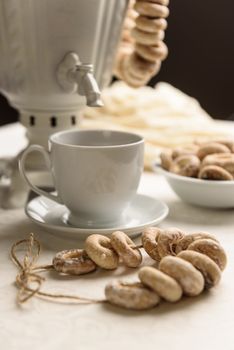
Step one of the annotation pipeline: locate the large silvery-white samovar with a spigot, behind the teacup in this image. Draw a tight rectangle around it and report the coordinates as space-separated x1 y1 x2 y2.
0 0 128 207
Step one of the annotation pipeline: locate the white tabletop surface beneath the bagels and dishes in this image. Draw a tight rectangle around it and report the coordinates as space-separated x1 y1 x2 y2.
0 125 234 350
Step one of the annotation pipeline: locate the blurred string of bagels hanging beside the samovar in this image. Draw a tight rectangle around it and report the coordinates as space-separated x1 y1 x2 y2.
114 0 169 88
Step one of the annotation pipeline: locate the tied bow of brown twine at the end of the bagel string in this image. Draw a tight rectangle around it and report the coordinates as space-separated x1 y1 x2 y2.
11 233 106 304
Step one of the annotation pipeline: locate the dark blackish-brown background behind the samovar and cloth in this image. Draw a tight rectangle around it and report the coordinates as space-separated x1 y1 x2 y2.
0 0 234 124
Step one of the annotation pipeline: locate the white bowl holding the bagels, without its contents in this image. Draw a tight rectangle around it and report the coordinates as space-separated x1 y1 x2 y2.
153 164 234 208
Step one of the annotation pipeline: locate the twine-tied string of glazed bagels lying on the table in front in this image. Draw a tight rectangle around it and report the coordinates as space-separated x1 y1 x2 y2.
11 227 227 310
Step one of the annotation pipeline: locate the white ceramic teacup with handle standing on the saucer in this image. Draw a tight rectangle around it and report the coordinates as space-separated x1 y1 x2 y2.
19 130 144 227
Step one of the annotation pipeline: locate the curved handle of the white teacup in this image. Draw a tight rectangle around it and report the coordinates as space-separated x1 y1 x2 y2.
19 145 63 204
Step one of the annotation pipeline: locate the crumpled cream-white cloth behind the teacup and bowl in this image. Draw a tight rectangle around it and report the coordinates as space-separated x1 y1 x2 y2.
81 82 234 168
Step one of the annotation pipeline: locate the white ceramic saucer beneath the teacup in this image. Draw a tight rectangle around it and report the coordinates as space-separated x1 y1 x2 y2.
25 194 169 239
